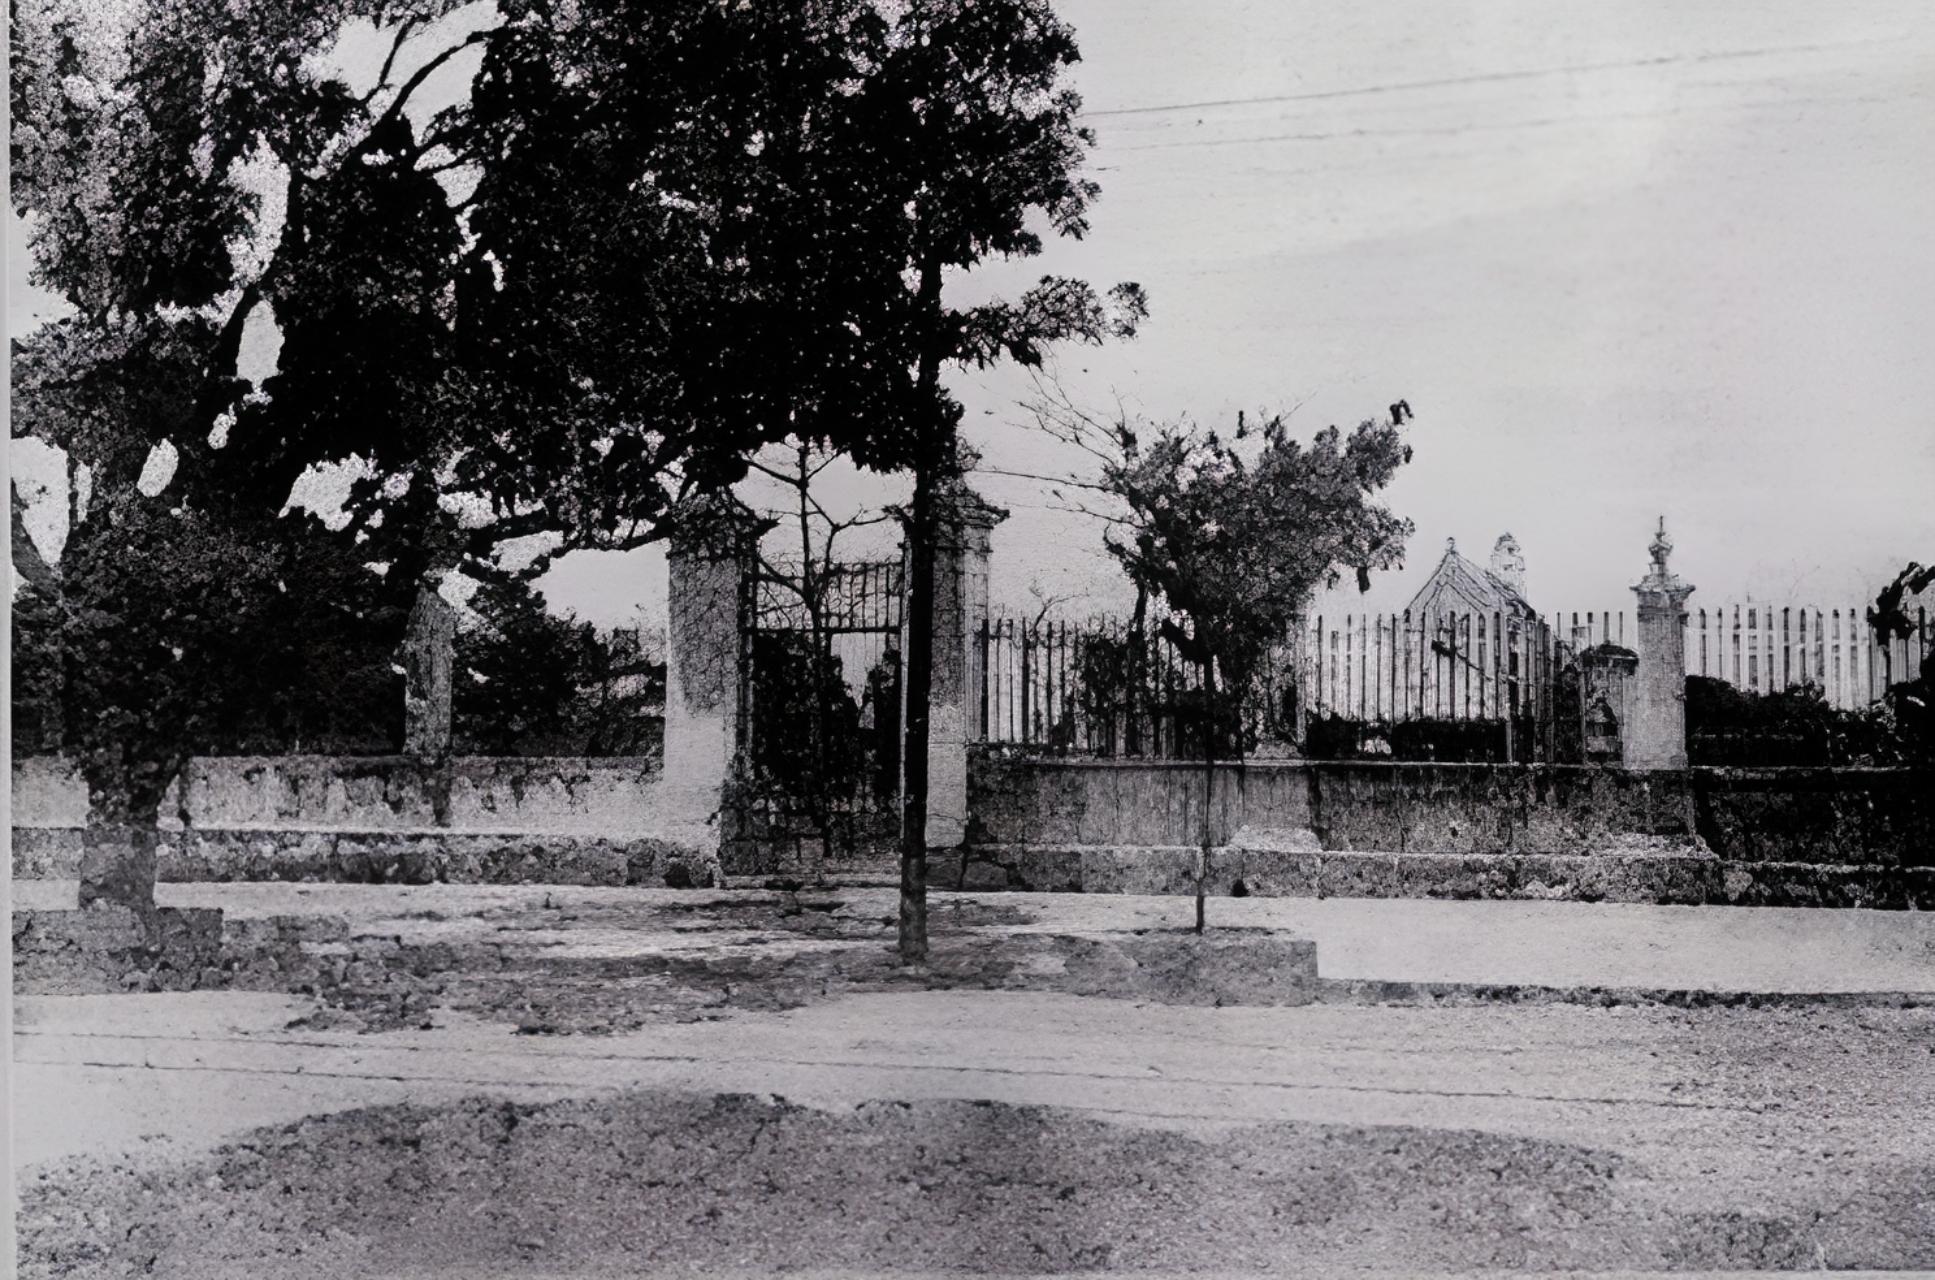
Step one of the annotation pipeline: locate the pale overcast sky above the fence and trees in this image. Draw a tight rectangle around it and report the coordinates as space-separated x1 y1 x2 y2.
10 0 1935 622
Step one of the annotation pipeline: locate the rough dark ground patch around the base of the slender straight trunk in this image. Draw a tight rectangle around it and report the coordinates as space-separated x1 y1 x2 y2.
280 897 1308 1034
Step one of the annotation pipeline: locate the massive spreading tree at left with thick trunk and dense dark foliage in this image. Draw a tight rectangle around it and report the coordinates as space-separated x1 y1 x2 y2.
12 0 982 904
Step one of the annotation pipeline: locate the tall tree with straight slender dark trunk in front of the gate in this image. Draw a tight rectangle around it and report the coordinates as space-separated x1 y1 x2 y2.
834 0 1146 962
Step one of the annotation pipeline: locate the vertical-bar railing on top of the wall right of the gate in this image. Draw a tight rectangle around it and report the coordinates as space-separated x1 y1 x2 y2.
975 602 1935 761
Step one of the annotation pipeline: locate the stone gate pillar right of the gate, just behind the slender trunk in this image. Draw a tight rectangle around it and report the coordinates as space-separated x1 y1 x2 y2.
902 480 1008 850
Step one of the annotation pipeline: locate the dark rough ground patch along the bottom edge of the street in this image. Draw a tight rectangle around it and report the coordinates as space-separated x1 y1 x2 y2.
19 1092 1935 1280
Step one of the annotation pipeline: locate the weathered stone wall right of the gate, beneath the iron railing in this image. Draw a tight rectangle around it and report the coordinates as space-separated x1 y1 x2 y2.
969 749 1935 868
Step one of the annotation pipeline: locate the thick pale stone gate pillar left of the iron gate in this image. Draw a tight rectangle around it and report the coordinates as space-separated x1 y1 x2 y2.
662 494 766 854
